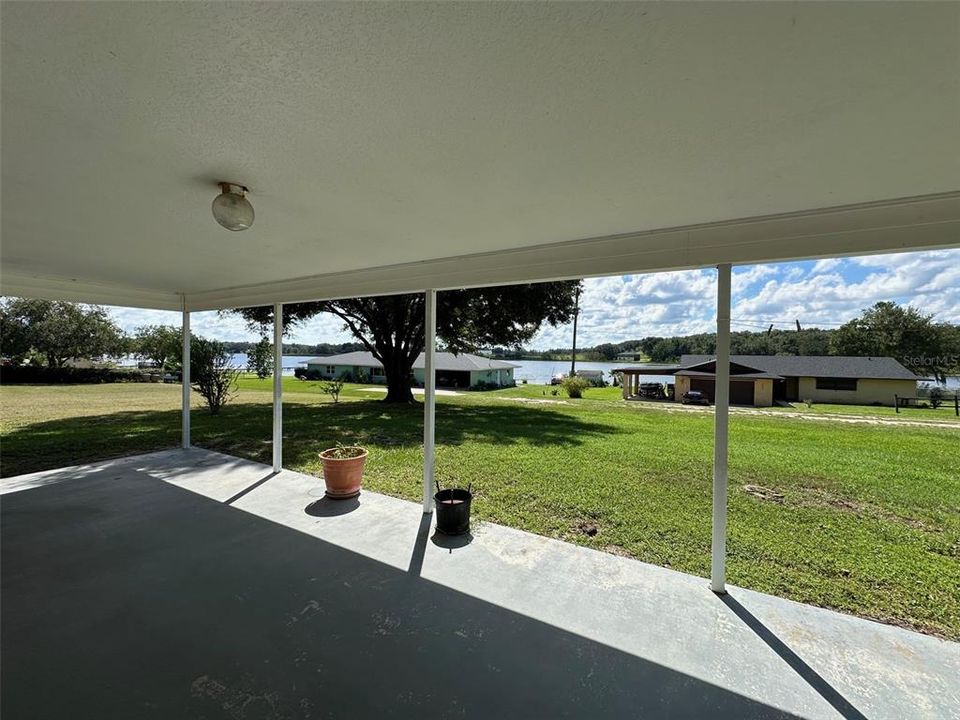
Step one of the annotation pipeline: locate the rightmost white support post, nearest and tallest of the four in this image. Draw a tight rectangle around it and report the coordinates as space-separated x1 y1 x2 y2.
710 263 730 593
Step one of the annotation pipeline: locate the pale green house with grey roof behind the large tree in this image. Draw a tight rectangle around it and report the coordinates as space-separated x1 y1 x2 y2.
306 352 520 388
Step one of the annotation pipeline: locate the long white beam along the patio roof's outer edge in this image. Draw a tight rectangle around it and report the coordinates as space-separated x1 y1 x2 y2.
2 192 960 310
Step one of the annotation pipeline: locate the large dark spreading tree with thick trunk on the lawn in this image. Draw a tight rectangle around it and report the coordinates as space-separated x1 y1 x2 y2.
233 280 580 403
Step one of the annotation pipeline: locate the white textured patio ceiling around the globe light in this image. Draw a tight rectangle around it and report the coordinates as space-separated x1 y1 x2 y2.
0 2 960 306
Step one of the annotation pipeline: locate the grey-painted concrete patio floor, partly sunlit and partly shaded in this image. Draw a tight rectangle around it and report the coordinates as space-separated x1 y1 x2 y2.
0 449 960 719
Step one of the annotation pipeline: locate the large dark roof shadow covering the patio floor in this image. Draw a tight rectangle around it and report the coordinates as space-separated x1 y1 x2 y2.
0 471 791 720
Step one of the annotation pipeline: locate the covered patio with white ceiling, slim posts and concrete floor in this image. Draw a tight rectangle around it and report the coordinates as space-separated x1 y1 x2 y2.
0 2 960 718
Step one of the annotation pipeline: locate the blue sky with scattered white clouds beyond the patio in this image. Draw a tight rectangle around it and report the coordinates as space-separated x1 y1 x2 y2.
109 249 960 349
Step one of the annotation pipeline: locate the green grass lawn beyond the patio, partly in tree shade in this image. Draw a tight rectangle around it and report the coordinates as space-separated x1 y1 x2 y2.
0 377 960 639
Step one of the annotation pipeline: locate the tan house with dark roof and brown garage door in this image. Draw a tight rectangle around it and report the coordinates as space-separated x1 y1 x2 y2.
619 355 921 407
